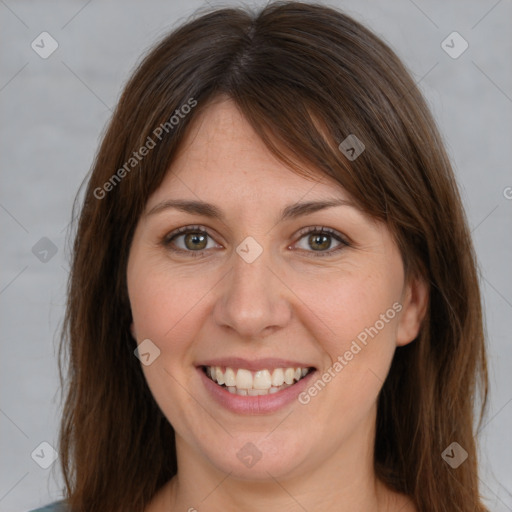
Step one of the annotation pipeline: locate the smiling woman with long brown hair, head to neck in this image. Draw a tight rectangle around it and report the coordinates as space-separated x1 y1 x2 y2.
31 2 487 512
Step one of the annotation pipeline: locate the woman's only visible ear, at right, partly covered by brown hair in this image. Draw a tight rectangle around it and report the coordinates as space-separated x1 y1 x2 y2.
396 277 429 347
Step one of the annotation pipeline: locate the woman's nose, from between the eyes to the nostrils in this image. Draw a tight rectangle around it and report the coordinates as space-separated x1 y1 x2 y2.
213 250 292 340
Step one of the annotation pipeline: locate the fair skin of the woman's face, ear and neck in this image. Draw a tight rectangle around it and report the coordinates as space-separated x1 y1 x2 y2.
127 100 427 512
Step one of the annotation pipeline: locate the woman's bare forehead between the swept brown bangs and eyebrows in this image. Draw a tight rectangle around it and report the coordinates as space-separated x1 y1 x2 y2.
148 99 350 208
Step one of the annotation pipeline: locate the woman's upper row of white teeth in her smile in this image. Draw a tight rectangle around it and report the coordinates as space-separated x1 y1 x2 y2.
206 366 308 390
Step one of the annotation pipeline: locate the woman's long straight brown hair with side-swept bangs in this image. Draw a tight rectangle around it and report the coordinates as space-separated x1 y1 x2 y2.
59 2 487 512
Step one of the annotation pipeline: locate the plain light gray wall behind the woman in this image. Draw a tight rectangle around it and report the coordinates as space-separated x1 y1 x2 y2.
0 0 512 512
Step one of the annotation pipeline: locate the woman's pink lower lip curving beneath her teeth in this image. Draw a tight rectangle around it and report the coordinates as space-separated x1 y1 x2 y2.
197 368 316 414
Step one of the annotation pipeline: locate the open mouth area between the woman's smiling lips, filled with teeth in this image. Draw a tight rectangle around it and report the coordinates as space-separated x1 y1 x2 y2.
201 366 315 396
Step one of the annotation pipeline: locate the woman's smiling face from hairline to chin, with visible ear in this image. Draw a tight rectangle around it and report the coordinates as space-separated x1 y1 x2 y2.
127 100 421 480
